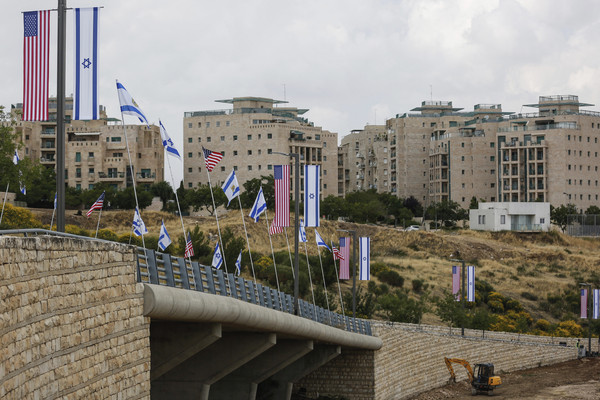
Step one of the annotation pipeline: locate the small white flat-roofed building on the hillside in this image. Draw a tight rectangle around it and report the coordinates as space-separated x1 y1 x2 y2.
469 202 550 232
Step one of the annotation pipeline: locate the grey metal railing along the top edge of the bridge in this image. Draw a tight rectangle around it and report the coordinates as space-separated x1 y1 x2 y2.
137 247 372 335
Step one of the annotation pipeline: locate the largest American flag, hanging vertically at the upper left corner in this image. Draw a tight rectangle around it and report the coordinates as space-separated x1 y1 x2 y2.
22 10 50 121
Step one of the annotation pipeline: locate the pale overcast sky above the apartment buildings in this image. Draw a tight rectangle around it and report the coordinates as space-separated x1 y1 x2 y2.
0 0 600 186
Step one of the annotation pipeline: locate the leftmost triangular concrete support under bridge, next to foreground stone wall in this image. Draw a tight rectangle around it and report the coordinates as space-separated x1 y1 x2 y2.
150 320 221 380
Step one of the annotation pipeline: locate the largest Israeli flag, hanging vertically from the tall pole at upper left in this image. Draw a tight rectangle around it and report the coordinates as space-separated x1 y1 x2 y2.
73 7 98 119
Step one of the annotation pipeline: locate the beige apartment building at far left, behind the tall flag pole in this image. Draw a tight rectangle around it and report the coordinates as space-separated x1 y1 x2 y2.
12 98 164 189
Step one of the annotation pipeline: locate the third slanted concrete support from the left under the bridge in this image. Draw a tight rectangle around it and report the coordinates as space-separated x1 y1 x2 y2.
210 340 313 400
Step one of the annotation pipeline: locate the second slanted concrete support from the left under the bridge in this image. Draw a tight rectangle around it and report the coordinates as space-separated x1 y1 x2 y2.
151 332 276 400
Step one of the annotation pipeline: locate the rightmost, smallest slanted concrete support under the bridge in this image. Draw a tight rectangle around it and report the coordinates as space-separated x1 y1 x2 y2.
258 345 342 400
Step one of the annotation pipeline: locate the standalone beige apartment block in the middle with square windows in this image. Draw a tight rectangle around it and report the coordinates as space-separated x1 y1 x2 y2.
183 97 338 197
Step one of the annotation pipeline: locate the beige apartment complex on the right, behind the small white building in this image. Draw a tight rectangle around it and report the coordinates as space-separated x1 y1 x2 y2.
338 95 600 210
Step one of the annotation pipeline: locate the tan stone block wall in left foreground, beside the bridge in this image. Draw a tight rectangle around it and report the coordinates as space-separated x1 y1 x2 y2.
0 236 150 399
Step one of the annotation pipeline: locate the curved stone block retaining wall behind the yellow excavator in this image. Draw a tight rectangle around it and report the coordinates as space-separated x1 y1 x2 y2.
295 323 577 400
